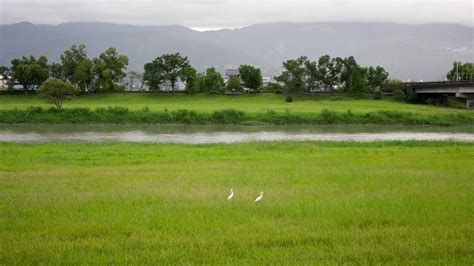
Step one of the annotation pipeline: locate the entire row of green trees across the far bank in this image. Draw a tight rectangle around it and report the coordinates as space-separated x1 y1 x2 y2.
0 44 474 102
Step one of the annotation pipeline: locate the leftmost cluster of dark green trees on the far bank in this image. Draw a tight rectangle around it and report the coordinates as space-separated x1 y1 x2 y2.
1 44 128 93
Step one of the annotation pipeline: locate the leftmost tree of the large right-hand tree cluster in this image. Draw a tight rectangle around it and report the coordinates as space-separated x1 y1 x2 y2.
275 56 307 91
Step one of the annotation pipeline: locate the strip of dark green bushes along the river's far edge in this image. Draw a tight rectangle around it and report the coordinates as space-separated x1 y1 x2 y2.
0 106 474 126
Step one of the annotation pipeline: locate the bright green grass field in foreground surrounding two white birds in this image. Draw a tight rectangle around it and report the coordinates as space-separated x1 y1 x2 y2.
0 142 474 265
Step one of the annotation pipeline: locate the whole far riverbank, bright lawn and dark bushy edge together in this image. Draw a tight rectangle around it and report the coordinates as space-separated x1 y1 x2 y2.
0 93 474 126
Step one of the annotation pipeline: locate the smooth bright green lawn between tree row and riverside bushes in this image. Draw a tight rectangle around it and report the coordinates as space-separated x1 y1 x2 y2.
0 93 472 113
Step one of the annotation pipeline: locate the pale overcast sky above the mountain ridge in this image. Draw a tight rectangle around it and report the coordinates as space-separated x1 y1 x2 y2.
0 0 474 29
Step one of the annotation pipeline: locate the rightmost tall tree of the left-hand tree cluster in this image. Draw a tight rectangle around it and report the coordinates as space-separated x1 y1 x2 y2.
92 47 128 92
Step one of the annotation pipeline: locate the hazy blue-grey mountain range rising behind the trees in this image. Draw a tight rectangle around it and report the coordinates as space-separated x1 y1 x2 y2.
0 22 474 80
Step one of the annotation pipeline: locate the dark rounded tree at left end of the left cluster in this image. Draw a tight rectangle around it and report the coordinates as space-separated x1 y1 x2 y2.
10 55 49 94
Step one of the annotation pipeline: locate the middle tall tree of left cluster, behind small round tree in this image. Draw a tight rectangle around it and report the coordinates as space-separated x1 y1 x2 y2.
56 44 94 92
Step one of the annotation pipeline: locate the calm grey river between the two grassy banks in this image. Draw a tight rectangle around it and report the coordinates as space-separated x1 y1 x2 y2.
0 124 474 144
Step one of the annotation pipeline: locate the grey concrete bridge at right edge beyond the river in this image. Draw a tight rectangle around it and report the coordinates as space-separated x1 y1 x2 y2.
403 81 474 108
